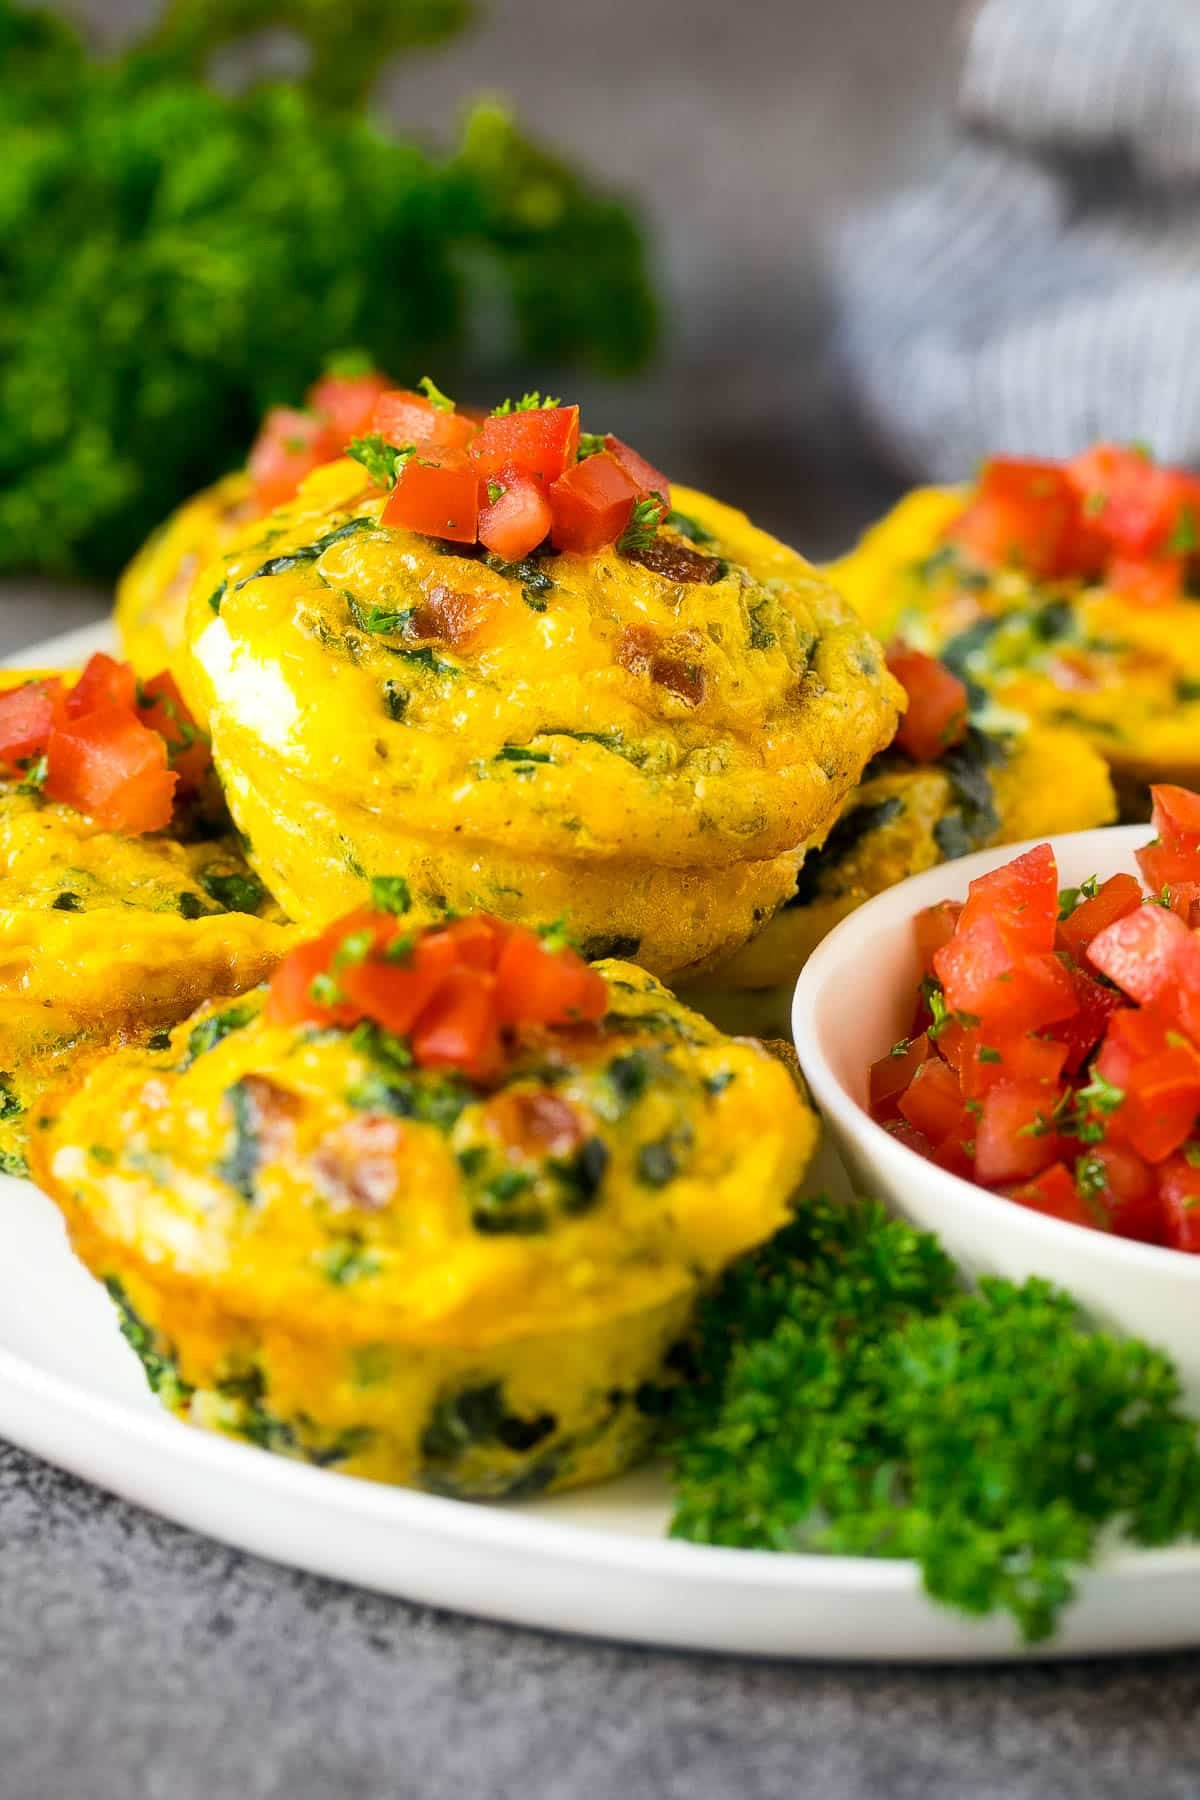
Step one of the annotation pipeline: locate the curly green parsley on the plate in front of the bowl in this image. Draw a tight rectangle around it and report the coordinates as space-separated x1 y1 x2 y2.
669 1199 1200 1642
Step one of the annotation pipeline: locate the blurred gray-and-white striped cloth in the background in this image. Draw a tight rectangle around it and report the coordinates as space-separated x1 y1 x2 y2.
831 0 1200 481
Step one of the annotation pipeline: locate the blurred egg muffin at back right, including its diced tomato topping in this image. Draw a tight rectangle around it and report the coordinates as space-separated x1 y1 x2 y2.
826 446 1200 814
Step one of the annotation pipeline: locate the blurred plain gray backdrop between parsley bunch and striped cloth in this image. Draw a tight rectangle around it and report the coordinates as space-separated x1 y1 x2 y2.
0 0 964 653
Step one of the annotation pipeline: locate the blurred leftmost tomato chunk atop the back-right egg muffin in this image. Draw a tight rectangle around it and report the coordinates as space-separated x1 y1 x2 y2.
948 457 1087 580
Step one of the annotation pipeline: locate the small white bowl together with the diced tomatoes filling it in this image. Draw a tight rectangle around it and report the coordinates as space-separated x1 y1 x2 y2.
793 787 1200 1404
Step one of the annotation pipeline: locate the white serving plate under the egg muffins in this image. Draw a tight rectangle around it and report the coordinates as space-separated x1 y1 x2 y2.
0 632 1200 1661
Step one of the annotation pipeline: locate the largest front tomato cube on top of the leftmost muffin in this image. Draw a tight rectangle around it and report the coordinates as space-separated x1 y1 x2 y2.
43 707 178 835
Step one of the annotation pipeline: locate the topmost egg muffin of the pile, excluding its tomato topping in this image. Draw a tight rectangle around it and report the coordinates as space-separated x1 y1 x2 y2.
189 459 900 976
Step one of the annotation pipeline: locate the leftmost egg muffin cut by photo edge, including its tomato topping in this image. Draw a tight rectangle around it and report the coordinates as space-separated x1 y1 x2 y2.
0 657 295 1174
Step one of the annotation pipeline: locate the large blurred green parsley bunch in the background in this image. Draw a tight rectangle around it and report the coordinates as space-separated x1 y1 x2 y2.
0 0 655 576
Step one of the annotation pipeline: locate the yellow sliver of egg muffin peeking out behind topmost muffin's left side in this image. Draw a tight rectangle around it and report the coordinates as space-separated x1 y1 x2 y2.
115 470 259 716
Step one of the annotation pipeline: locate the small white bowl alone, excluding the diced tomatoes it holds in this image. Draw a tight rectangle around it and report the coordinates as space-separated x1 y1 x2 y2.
792 824 1200 1409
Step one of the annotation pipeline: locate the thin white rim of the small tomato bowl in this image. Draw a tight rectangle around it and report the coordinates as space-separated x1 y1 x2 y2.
792 824 1200 1289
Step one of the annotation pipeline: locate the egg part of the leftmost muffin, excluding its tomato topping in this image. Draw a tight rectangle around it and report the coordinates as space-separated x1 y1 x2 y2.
0 673 295 1174
